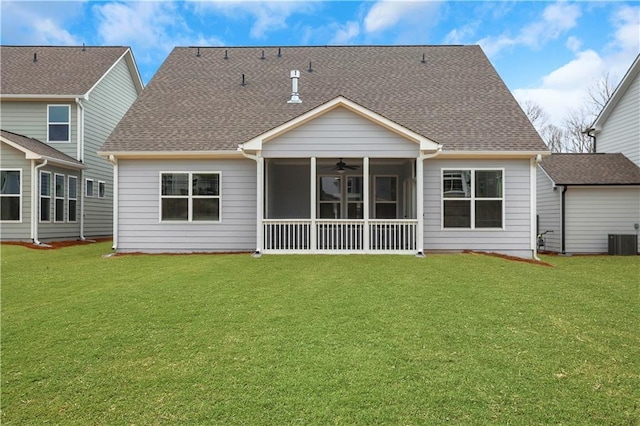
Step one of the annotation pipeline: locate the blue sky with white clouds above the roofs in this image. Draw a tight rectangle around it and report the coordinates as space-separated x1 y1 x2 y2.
0 0 640 125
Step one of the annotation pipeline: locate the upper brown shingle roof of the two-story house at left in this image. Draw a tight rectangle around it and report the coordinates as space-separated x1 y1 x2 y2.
0 46 142 98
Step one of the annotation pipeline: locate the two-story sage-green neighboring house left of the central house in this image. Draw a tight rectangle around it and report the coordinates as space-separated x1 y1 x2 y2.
0 46 143 243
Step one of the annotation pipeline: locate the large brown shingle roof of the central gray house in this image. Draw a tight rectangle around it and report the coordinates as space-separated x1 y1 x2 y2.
102 46 547 153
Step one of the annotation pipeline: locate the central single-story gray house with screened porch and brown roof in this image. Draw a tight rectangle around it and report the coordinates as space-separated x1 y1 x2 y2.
100 46 548 258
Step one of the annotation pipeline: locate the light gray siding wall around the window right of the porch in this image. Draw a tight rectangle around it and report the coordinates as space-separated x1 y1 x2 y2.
424 159 532 257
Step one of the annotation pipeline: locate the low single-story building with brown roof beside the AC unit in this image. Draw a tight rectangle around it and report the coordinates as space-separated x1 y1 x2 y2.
537 154 640 254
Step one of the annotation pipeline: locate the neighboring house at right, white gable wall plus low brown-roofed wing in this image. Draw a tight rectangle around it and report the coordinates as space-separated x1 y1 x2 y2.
537 55 640 254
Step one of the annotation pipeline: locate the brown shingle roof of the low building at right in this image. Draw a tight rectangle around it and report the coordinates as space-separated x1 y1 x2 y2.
540 154 640 185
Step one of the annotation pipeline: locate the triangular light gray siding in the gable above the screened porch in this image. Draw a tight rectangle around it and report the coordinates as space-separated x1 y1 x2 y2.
262 107 419 158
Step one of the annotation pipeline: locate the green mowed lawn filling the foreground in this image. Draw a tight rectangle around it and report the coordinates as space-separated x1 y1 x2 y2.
1 243 640 425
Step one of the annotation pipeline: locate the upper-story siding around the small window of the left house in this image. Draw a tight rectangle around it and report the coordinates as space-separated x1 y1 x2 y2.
0 101 78 159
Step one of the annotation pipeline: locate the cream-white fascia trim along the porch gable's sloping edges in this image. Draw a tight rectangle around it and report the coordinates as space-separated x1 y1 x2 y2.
240 96 440 151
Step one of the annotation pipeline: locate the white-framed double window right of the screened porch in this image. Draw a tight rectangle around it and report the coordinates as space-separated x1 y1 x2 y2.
442 169 504 229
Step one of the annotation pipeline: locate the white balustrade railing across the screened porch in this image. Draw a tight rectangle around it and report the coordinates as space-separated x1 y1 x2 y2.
262 219 418 253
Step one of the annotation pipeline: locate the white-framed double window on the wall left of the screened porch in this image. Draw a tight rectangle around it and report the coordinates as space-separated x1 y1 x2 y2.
160 172 220 222
